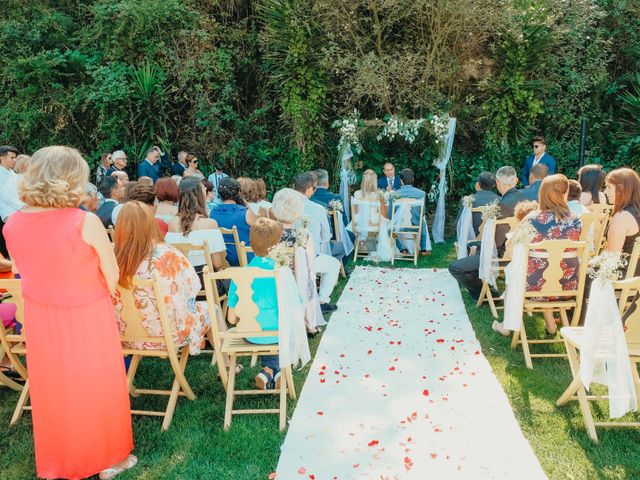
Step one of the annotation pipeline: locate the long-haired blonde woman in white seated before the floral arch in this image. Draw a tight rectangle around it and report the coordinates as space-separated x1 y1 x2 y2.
352 169 391 262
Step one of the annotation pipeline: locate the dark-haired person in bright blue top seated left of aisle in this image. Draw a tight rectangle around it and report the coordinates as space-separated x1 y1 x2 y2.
209 177 257 267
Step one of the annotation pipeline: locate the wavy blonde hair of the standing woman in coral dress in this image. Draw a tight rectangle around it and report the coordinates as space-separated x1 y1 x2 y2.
18 145 89 208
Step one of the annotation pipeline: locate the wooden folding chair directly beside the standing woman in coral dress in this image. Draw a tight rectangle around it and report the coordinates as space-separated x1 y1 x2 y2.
118 278 195 430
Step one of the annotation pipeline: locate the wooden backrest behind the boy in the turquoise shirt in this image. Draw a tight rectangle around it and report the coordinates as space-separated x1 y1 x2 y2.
204 267 278 338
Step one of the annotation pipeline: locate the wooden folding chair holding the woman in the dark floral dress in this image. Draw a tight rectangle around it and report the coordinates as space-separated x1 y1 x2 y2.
511 240 589 368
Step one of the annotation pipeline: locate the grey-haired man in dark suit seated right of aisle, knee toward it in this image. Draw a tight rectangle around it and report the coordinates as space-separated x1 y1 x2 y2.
449 167 525 301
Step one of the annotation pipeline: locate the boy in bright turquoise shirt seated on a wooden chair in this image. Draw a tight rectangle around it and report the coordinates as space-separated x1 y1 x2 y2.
228 218 300 390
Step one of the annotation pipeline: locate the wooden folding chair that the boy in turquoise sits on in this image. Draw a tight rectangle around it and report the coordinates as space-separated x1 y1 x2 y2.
205 267 296 431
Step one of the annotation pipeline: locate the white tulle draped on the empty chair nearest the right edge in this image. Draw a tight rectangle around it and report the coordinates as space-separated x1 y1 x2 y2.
580 278 638 418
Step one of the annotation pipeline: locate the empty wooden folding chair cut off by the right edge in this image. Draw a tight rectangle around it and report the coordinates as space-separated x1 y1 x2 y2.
556 277 640 443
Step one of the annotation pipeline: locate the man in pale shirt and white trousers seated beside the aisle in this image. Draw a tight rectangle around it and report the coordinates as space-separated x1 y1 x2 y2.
294 172 340 312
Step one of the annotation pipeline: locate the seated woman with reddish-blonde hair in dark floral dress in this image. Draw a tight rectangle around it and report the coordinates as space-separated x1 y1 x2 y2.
493 174 582 335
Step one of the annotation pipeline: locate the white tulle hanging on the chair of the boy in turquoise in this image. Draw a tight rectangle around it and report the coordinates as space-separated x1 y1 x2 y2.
277 267 311 368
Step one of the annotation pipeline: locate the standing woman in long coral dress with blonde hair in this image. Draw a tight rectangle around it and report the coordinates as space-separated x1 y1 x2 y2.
4 147 137 479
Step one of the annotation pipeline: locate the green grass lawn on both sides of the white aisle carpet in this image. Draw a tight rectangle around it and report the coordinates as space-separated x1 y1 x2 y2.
0 243 640 480
